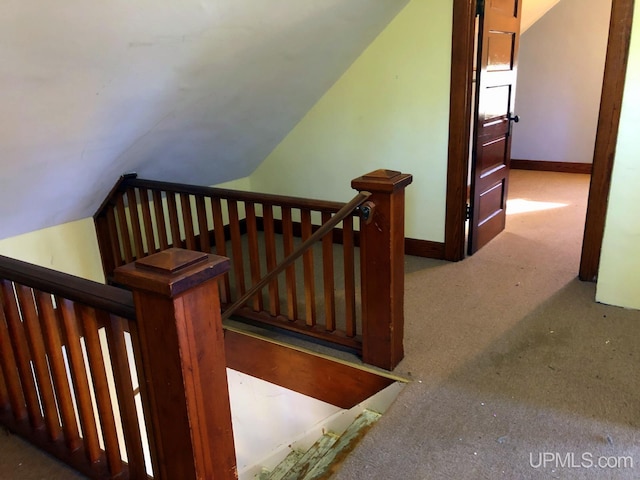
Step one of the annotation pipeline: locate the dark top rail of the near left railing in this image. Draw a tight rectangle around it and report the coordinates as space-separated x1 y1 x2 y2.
0 255 136 320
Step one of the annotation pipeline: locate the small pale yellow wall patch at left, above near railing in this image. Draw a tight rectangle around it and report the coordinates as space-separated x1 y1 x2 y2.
0 218 104 282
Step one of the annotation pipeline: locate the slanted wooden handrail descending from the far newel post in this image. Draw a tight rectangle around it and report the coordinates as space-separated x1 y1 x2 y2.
222 191 371 320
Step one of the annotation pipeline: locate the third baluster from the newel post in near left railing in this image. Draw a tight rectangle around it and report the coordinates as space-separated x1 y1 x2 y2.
56 297 101 463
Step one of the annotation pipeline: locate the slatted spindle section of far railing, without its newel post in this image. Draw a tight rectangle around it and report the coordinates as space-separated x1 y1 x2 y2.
96 178 361 350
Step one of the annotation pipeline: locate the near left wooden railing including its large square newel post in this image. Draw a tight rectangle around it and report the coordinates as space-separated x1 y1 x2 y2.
0 249 237 480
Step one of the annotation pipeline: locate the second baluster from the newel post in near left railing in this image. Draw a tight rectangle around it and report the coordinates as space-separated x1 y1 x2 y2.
76 305 123 477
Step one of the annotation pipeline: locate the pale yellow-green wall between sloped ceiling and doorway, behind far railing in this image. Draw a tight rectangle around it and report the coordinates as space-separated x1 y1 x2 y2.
250 0 453 242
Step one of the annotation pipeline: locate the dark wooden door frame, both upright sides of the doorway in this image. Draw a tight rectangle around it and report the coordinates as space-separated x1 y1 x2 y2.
444 0 634 281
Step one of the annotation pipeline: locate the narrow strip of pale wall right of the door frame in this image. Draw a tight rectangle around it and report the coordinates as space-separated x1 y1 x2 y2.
596 3 640 309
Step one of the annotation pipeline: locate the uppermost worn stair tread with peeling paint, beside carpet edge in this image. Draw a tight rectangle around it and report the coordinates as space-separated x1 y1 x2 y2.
299 410 381 480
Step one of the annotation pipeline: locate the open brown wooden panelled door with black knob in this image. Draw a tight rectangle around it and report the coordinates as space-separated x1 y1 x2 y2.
468 0 522 255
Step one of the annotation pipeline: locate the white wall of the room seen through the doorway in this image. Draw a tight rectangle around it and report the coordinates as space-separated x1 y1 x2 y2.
511 0 611 163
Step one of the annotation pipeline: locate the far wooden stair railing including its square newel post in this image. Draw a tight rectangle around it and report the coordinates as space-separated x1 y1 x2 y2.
94 170 412 369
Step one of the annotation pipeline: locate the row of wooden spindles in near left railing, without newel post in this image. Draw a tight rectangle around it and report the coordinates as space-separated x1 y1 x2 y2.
0 257 152 479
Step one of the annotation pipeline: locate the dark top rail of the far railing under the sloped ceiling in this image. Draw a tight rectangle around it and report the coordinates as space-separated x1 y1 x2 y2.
96 174 356 215
